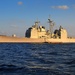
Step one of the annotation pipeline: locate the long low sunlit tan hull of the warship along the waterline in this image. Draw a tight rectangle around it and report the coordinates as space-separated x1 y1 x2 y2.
0 35 75 43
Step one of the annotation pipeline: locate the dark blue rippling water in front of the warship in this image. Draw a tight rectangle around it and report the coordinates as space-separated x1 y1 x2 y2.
0 43 75 75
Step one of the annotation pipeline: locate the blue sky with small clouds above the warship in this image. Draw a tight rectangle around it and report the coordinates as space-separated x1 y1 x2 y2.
0 0 75 37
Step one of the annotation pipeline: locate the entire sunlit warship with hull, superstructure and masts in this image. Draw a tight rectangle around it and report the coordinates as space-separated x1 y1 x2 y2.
0 18 75 43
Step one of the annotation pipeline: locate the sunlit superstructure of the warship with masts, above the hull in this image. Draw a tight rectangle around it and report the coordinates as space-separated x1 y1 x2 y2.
25 19 67 39
